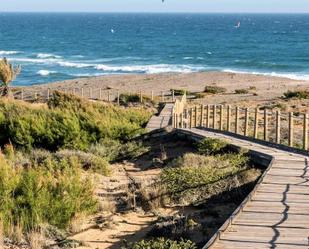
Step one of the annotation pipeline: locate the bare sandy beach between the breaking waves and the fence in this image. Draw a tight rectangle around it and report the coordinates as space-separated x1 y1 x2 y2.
25 72 309 103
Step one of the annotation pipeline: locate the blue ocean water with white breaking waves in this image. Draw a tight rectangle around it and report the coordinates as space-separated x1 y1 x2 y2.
0 13 309 85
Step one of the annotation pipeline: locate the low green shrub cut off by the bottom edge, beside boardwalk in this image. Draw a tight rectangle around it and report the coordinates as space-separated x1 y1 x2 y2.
121 238 197 249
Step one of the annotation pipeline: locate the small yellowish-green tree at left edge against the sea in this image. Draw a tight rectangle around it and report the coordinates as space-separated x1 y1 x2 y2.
0 58 21 96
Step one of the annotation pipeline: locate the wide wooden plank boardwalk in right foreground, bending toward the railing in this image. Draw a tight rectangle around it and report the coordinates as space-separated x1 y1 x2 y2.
179 128 309 249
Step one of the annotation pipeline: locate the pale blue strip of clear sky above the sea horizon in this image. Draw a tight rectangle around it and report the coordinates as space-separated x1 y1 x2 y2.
0 0 309 13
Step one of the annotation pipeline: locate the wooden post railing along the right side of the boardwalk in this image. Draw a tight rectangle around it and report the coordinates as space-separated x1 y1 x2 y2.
173 105 309 150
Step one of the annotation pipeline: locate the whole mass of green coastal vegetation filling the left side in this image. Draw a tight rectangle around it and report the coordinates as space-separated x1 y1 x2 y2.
0 92 152 248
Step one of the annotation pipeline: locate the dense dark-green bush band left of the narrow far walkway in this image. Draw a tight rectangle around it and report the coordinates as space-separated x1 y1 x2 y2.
0 92 151 151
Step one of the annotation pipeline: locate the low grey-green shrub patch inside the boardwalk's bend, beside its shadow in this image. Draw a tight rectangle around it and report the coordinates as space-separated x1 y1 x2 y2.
160 153 249 202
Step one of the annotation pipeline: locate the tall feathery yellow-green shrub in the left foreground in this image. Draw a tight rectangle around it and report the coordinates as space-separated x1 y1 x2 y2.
0 155 97 236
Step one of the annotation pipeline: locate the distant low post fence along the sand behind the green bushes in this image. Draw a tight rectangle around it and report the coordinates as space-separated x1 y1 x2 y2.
13 87 176 104
